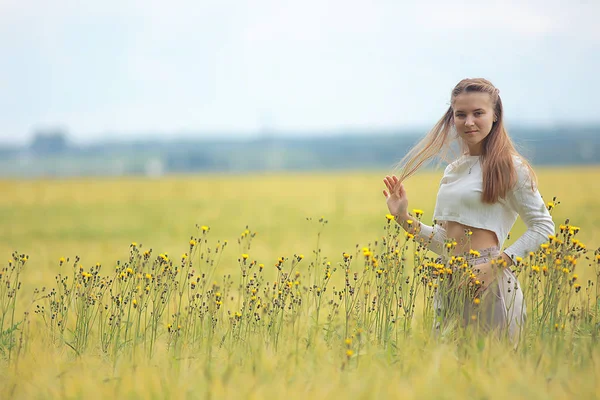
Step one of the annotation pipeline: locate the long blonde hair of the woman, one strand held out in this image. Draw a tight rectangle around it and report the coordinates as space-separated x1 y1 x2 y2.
396 78 537 204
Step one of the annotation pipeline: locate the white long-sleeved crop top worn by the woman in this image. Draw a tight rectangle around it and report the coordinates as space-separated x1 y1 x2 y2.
419 155 555 260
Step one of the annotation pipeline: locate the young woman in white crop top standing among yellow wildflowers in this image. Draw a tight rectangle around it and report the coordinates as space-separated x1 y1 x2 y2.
383 79 555 340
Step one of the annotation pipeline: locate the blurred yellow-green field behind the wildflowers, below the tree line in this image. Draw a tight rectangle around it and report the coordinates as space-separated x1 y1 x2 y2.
0 167 600 286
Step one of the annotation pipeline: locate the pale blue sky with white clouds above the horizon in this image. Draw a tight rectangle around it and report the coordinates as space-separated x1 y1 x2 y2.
0 0 600 144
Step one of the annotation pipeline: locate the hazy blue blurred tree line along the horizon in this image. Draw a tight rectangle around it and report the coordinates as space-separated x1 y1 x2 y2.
0 125 600 176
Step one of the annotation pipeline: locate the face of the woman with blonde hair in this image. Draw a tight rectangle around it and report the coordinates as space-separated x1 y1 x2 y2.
452 92 496 155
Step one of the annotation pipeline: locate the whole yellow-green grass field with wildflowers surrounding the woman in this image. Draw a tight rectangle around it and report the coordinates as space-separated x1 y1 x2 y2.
0 167 600 399
